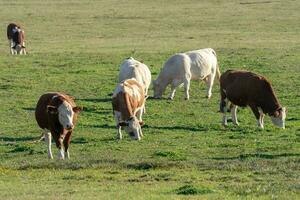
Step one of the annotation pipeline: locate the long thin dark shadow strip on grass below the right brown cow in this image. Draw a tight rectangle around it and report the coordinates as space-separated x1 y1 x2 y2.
212 153 300 160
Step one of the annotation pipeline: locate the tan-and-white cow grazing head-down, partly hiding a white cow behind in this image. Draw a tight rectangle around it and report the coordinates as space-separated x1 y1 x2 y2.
112 78 146 140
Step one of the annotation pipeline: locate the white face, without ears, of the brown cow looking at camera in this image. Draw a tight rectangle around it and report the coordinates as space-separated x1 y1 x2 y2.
57 101 74 130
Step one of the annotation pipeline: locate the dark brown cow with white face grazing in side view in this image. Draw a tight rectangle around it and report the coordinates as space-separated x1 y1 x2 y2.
220 70 286 129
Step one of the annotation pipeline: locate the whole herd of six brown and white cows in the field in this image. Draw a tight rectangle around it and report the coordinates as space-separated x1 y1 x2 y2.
7 24 286 159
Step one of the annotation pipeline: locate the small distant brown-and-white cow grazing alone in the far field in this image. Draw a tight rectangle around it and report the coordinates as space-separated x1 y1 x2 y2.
7 23 26 55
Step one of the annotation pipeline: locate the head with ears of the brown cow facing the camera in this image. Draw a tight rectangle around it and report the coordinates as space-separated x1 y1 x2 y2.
47 101 82 130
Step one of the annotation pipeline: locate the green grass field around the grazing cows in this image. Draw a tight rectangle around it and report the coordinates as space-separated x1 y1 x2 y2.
0 0 300 200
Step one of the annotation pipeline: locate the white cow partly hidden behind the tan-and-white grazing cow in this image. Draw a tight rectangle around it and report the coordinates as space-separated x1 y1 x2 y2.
119 57 151 96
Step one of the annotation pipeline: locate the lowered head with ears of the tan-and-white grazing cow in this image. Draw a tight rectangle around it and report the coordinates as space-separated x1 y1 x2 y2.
119 117 144 140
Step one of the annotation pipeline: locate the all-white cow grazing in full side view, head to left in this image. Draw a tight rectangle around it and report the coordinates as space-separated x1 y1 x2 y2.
153 48 220 100
